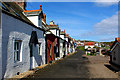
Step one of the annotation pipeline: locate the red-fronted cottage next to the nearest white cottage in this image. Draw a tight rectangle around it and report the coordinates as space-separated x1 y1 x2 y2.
46 31 57 63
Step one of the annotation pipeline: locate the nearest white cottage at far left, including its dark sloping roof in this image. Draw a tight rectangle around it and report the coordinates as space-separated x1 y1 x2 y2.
0 2 45 79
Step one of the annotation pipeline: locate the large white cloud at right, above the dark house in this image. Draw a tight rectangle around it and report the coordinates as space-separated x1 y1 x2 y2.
81 13 118 40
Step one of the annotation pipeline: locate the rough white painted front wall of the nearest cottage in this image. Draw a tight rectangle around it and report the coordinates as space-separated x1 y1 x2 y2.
2 13 45 78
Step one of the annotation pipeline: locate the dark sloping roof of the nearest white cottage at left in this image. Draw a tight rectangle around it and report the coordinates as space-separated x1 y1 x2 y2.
1 2 44 31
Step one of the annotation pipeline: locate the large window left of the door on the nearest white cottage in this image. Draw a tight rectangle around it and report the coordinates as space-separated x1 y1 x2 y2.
14 40 22 62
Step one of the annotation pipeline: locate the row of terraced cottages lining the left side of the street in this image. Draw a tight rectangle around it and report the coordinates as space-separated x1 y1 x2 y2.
0 2 75 79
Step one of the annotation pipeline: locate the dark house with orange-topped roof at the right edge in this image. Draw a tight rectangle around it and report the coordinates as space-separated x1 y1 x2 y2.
110 38 120 66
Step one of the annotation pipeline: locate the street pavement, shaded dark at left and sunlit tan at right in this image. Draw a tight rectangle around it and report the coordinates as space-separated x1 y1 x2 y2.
24 50 118 78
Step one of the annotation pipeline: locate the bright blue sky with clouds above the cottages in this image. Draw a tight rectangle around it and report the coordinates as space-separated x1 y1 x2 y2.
26 2 118 41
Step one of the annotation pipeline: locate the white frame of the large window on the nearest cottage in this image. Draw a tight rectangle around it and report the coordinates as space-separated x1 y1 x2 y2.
13 38 23 62
